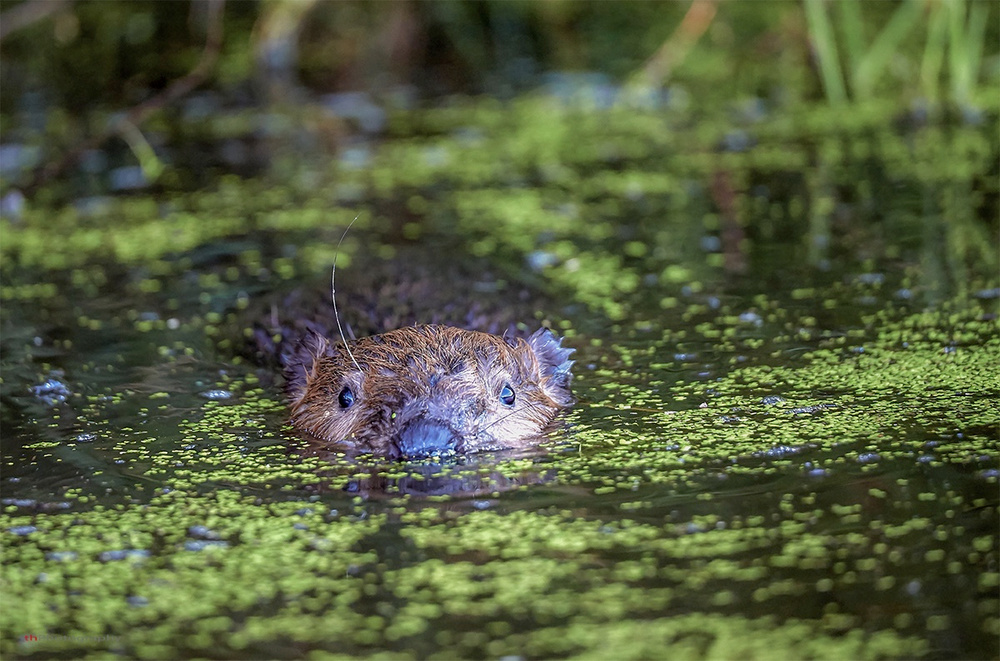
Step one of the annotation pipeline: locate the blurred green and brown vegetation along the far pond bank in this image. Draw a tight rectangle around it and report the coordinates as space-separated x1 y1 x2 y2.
0 0 1000 190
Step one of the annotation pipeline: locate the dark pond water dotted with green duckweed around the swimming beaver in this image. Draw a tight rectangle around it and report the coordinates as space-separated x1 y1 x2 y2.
0 94 1000 659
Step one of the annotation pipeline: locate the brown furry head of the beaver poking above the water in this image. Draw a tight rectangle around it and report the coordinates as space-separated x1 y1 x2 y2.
285 325 573 458
